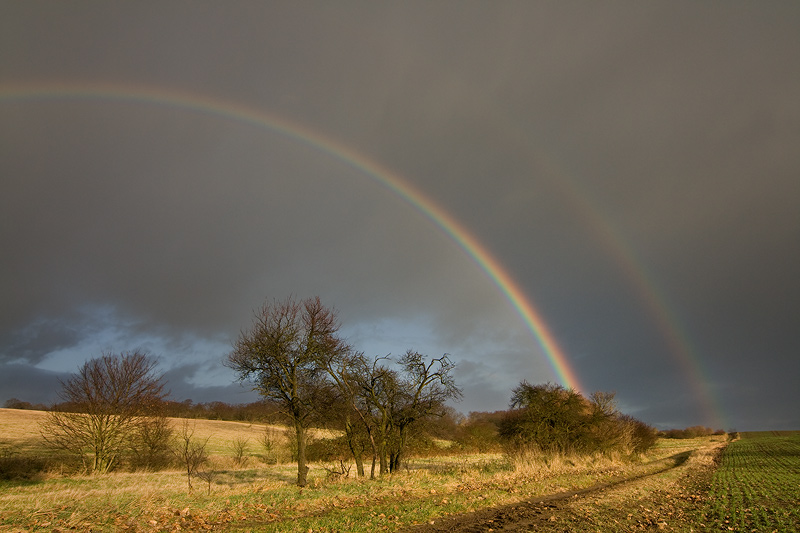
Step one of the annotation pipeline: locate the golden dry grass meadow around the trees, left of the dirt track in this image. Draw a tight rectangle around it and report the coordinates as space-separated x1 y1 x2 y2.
0 409 724 532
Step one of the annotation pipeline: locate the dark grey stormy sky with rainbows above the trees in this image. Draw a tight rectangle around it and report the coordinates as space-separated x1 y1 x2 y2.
0 1 800 430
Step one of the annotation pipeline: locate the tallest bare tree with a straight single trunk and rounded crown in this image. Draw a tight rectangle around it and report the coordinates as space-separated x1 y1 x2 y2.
225 297 350 487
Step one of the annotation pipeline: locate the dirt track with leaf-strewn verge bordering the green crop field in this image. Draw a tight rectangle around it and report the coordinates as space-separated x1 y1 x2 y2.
406 444 724 533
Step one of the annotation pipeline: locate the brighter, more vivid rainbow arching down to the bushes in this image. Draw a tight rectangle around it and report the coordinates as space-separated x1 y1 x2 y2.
0 82 583 391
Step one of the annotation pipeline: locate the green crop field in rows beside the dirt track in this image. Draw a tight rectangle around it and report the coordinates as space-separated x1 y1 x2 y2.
704 432 800 532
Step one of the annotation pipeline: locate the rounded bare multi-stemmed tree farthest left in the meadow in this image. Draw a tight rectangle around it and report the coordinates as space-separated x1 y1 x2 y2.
41 351 166 473
